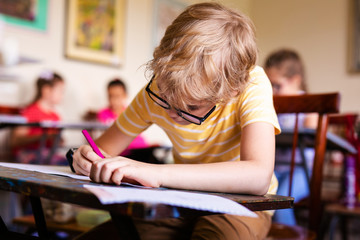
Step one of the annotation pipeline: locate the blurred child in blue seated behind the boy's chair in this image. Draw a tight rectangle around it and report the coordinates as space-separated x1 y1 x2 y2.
265 49 317 225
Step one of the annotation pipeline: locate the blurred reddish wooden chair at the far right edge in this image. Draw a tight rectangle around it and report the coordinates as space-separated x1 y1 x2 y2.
322 113 360 239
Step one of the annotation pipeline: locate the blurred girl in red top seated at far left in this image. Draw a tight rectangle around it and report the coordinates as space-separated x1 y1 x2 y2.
10 71 67 165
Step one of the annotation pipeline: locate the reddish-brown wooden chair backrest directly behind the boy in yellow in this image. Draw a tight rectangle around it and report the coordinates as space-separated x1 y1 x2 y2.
273 93 340 231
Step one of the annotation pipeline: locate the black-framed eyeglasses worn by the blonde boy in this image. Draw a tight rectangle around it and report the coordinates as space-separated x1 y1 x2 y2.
146 76 216 125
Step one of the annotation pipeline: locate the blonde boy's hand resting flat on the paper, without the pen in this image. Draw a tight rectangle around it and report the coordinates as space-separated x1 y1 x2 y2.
90 157 160 187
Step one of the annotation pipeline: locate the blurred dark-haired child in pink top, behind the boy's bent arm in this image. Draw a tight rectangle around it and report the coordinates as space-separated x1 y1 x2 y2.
97 78 148 156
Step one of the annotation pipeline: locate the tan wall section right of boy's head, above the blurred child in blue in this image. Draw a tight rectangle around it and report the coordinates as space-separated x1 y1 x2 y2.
250 0 360 113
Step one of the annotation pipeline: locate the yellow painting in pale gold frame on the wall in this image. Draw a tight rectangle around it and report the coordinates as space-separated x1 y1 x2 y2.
65 0 125 67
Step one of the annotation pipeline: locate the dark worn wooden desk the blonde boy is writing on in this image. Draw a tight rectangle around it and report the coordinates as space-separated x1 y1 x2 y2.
0 166 294 239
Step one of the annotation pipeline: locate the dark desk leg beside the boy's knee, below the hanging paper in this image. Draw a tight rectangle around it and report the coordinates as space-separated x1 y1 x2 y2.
111 213 140 240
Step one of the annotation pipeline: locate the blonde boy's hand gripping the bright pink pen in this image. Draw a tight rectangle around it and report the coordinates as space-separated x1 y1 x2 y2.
73 145 102 176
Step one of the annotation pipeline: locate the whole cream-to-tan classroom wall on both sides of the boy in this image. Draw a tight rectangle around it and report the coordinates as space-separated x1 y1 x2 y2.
0 0 360 148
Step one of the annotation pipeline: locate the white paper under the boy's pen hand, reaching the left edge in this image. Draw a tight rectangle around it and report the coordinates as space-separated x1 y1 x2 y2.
0 162 90 181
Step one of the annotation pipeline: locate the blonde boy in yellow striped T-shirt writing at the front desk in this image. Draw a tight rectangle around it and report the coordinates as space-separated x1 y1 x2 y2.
74 3 280 239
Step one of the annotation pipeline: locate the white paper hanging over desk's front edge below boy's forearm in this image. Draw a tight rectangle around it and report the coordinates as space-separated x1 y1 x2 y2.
84 185 257 217
